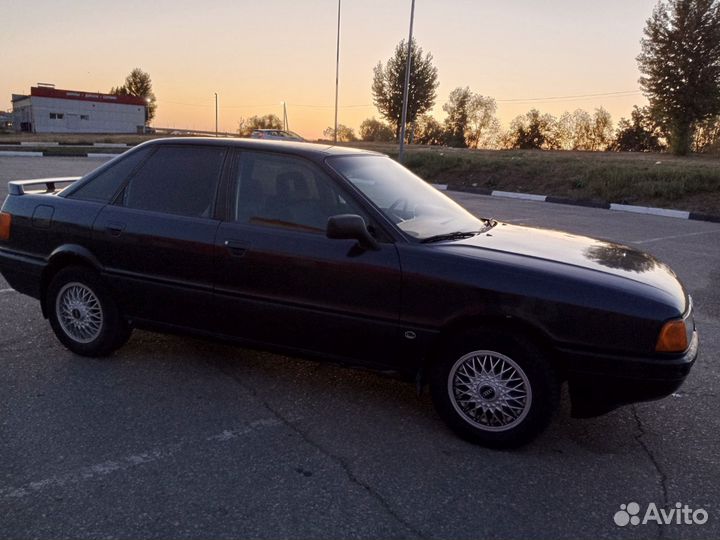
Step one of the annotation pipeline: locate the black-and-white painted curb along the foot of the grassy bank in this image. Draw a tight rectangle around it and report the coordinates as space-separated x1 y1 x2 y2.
433 184 720 223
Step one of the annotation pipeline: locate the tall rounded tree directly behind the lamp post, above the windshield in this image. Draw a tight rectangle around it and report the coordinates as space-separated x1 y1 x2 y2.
372 38 439 138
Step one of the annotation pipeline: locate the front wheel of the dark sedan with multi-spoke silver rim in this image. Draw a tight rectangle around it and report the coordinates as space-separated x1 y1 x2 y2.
430 333 560 448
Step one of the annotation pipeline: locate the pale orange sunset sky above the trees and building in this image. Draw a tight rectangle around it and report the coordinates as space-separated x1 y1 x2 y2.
0 0 657 139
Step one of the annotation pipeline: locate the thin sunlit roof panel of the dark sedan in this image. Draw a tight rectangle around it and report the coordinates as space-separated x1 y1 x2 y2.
142 137 385 158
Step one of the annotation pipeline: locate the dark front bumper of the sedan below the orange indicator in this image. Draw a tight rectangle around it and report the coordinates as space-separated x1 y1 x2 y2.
566 331 699 418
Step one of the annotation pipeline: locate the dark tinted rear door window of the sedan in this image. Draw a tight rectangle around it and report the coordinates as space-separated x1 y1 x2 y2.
123 146 225 217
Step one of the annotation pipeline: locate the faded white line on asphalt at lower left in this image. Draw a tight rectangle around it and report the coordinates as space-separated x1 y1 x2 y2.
0 417 286 499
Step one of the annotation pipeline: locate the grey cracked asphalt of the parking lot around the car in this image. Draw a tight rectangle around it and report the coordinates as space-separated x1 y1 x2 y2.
0 154 720 539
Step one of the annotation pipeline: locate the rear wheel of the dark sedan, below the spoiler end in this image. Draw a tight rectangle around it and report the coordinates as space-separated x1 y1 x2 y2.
45 266 131 356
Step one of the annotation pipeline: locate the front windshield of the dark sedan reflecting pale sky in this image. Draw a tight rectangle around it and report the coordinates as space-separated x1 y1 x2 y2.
328 155 487 240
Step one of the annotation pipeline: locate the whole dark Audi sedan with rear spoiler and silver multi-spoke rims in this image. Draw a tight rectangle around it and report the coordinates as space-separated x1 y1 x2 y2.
0 138 698 447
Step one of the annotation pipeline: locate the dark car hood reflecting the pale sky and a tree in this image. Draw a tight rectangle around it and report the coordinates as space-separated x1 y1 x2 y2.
453 223 686 298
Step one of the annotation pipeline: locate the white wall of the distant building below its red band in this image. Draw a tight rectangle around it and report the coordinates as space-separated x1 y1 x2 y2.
18 96 145 133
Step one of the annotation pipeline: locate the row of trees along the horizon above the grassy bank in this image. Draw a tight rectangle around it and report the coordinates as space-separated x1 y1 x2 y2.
350 0 720 155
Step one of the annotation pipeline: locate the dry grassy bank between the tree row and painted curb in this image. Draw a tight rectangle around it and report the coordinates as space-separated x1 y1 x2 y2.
338 143 720 215
